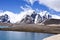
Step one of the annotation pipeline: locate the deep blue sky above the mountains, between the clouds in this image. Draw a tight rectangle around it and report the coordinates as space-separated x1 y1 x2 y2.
0 0 60 15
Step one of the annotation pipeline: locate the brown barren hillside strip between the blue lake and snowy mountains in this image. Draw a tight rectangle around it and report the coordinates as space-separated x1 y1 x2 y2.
0 23 60 33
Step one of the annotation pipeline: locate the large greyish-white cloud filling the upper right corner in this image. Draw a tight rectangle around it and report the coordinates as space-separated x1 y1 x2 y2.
39 0 60 12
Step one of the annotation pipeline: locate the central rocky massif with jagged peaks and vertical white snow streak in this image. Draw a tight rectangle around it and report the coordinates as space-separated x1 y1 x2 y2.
19 11 51 24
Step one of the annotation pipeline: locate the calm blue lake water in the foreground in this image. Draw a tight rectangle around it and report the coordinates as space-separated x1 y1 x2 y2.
0 31 53 40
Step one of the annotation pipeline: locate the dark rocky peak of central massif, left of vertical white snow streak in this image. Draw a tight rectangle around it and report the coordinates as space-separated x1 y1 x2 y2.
20 11 37 24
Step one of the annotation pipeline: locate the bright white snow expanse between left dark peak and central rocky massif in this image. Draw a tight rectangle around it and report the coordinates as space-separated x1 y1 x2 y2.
0 10 34 23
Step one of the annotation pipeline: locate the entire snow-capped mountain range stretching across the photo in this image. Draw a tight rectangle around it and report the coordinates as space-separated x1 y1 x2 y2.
0 10 60 24
